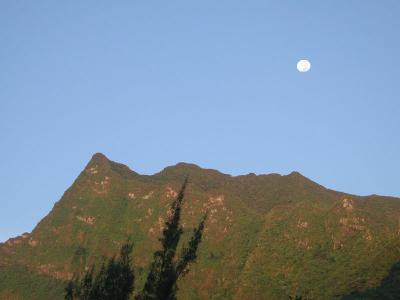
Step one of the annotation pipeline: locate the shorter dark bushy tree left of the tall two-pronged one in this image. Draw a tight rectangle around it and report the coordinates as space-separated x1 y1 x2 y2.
65 241 135 300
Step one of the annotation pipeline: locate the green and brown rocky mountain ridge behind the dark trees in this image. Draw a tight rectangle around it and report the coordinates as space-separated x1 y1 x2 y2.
0 153 400 300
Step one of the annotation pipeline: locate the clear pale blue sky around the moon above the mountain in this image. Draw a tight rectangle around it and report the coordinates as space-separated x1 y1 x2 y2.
0 0 400 241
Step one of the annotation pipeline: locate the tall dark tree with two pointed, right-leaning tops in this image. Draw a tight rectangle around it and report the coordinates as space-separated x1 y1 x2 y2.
136 178 207 300
